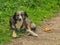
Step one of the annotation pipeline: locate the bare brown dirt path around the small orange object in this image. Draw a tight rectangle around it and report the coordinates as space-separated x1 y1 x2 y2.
6 14 60 45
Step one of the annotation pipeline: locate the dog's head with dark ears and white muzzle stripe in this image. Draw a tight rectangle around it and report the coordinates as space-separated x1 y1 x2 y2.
13 11 28 21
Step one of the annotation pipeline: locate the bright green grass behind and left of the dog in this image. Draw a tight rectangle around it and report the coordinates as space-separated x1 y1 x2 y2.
0 0 60 45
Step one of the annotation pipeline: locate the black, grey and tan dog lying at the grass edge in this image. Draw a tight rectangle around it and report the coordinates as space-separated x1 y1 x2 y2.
10 11 38 37
